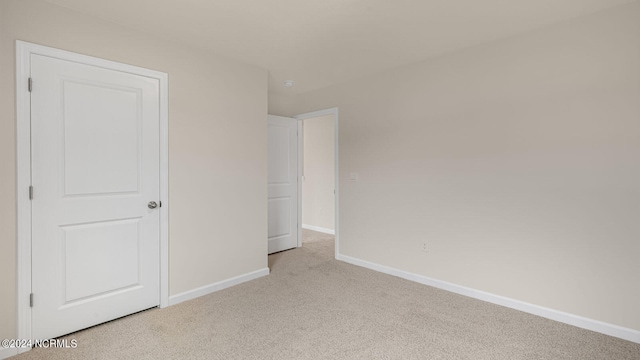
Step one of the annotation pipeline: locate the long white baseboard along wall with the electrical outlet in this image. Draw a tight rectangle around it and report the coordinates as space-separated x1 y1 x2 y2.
337 254 640 344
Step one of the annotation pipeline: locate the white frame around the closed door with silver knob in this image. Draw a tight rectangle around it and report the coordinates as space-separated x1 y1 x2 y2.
16 40 169 353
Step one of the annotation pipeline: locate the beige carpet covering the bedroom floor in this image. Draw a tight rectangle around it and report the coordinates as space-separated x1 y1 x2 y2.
12 231 640 360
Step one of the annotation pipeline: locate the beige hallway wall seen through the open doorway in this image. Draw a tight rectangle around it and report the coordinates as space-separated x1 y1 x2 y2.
302 115 335 230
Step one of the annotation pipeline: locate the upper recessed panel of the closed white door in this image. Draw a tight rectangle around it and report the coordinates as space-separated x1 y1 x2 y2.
62 79 142 195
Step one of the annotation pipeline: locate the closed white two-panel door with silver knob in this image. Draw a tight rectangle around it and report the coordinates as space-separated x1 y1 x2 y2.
31 55 160 339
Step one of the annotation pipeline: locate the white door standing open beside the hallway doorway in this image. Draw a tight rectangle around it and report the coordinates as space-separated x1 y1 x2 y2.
268 115 298 254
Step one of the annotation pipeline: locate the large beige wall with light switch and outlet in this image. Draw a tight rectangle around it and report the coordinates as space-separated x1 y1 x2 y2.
294 2 640 330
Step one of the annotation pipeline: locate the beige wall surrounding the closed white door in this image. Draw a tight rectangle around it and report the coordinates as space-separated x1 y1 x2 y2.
0 0 267 338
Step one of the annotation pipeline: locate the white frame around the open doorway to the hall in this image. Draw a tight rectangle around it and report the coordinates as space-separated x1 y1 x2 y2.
294 107 340 259
